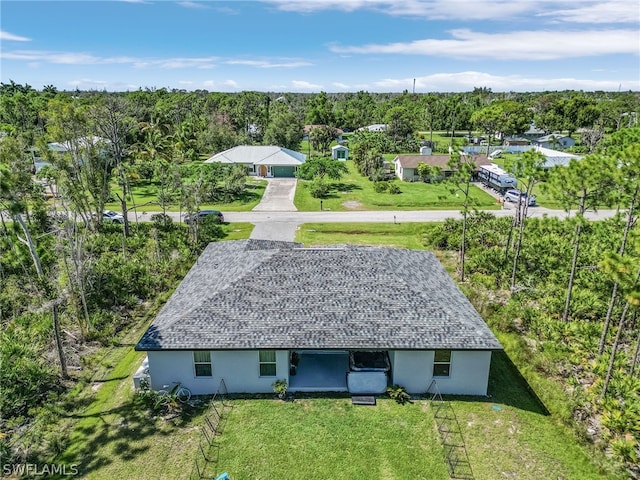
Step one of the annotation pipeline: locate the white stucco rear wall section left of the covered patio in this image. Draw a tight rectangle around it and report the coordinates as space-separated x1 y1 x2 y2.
148 350 289 395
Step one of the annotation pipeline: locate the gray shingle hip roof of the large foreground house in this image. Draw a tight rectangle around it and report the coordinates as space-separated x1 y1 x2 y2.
136 240 502 350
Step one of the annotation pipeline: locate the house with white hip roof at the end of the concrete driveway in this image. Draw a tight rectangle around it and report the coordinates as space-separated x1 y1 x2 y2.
204 145 307 177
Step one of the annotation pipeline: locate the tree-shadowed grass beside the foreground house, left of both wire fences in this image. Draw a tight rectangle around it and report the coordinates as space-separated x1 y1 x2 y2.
52 316 208 479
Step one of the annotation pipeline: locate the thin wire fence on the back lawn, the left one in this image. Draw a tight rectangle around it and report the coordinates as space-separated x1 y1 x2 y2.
189 379 231 480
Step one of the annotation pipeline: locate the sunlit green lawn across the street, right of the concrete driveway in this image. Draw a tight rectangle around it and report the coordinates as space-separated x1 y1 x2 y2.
294 161 500 212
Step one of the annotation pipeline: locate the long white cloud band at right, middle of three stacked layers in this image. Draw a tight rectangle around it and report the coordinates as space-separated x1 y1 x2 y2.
330 29 640 60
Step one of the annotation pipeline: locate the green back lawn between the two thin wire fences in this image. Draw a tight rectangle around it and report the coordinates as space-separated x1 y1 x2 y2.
207 396 449 480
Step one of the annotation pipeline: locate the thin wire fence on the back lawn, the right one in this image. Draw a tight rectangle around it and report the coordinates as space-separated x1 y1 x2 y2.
427 380 474 480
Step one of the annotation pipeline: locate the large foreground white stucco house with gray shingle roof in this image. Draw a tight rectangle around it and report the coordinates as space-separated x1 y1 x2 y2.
135 240 502 395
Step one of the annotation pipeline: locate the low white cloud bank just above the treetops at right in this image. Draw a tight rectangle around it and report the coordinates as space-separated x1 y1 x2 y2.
373 71 638 93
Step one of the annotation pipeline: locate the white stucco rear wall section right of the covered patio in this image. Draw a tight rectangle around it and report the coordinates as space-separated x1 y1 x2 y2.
391 350 491 395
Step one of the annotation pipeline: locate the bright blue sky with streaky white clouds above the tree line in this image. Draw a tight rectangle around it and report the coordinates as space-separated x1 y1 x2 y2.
0 0 640 93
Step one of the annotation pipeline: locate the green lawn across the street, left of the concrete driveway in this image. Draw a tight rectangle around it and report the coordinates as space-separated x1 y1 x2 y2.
105 177 267 212
